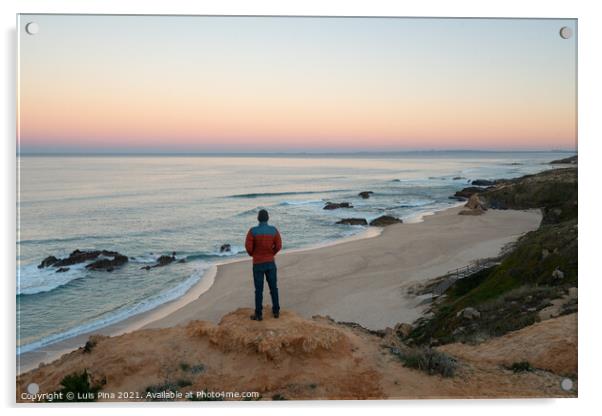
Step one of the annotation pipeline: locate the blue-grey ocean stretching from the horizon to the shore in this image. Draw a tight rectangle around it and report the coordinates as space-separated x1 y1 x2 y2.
16 151 571 354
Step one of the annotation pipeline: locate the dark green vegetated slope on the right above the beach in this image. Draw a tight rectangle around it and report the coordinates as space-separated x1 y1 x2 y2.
405 168 578 345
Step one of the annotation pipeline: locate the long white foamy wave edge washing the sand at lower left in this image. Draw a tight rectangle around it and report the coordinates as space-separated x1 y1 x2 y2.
17 264 209 355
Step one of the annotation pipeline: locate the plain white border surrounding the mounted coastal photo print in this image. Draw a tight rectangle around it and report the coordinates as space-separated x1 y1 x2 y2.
0 0 602 416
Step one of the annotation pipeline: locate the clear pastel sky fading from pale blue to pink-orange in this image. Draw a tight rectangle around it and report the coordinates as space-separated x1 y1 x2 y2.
18 15 577 153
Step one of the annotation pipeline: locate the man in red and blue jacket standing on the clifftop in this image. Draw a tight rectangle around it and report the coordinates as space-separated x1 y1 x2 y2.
245 209 282 321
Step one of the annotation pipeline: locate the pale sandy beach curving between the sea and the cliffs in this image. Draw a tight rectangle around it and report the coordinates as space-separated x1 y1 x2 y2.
18 207 541 373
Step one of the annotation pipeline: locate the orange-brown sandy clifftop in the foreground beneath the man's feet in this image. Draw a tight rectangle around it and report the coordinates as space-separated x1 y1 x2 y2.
17 309 576 402
